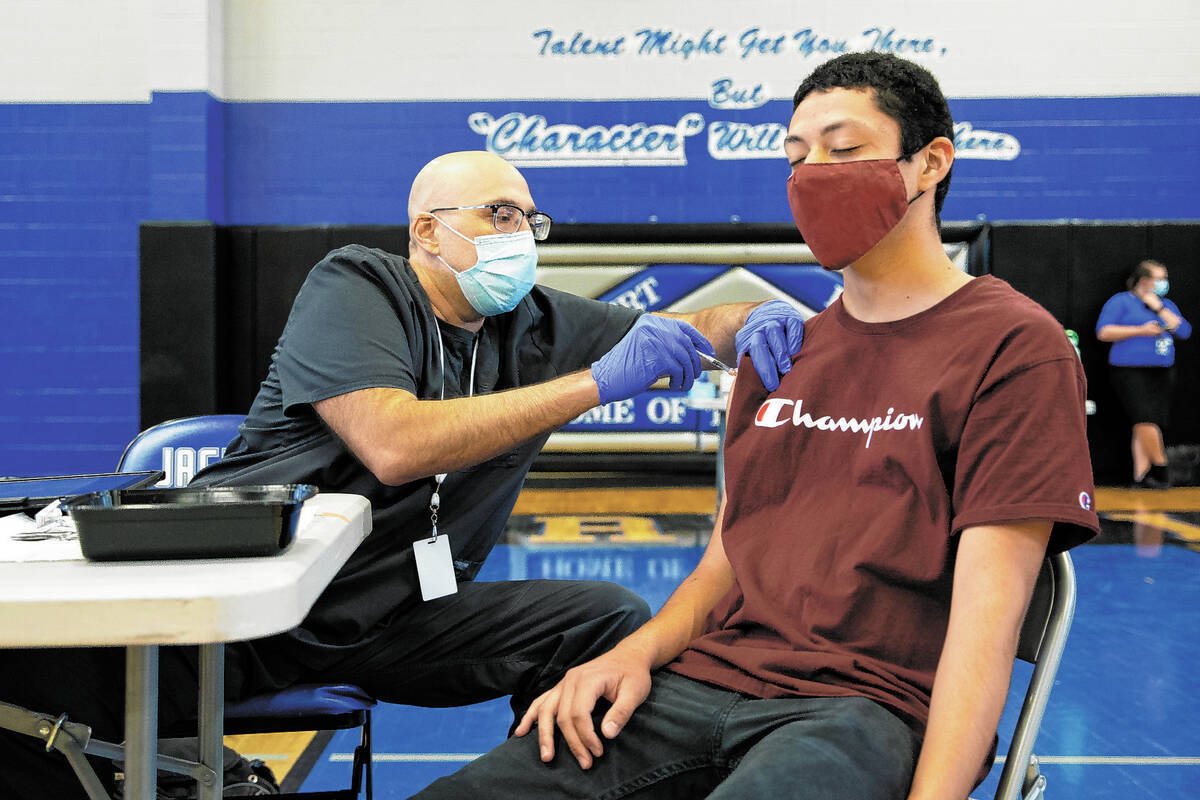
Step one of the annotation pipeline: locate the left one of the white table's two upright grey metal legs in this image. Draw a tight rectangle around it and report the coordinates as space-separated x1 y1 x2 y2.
125 644 158 800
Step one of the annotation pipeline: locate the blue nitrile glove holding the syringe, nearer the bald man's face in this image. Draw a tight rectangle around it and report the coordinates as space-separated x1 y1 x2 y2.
592 314 714 403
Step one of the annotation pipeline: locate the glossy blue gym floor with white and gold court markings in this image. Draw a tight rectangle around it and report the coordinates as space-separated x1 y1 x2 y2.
292 511 1200 800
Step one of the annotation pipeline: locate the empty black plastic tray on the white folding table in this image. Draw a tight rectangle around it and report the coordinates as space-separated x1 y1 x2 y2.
62 483 317 561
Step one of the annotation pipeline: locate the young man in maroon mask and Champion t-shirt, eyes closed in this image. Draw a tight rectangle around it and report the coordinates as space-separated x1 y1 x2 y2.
418 53 1098 800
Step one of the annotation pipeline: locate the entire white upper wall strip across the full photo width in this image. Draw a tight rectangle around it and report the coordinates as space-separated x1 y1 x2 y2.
0 0 1200 102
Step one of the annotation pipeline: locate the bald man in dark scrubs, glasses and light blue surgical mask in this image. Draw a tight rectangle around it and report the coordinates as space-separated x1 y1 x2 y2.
0 152 802 798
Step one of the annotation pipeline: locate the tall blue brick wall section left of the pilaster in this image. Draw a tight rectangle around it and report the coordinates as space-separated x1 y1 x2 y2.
0 104 149 475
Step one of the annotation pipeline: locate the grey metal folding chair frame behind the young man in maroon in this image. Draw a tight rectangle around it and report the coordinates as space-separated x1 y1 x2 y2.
996 553 1075 800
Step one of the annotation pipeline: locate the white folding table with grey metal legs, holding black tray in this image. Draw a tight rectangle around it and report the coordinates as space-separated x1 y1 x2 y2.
0 494 371 800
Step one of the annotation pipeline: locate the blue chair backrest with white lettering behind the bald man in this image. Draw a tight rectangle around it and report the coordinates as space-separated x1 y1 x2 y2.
116 414 246 488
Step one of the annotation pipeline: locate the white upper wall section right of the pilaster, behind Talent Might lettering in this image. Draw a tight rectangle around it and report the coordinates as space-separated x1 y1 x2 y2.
227 0 1200 100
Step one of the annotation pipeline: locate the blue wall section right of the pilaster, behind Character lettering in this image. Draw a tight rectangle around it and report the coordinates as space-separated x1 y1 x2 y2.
218 96 1200 224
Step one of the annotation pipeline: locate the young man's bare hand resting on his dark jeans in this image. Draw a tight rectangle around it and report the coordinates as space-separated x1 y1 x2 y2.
514 645 650 769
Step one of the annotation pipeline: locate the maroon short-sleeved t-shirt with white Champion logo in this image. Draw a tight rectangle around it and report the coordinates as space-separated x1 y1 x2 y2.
668 277 1099 735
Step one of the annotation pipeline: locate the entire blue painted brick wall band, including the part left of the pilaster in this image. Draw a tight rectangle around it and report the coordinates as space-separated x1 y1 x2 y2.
0 92 1200 475
